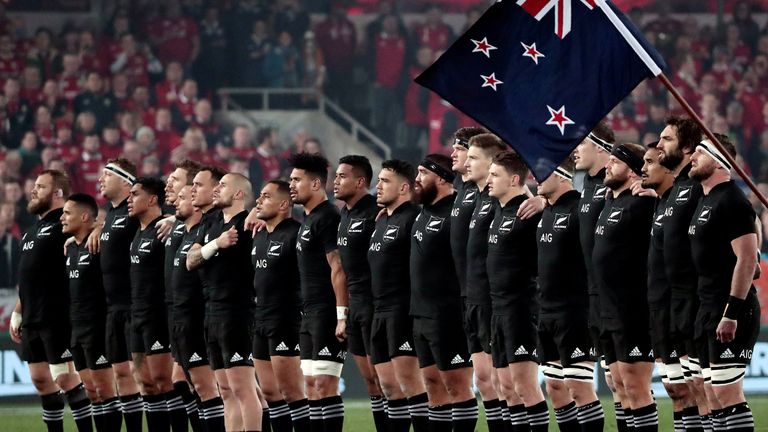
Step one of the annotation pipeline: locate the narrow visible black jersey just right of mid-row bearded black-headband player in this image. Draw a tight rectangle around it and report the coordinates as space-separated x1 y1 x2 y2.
451 176 480 297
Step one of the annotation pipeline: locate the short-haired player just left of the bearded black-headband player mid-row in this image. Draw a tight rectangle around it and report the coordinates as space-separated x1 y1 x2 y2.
368 160 429 432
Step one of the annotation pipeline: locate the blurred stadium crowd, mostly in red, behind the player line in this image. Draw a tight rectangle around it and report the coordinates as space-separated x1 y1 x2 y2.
0 0 768 280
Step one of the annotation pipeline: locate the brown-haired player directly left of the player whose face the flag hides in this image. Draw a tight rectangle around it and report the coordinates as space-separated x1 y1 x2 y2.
487 151 549 431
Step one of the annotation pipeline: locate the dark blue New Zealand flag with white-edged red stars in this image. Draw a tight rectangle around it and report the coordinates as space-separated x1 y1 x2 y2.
416 0 666 181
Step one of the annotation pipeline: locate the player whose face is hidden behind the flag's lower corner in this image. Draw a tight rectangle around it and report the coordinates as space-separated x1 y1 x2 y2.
536 158 605 432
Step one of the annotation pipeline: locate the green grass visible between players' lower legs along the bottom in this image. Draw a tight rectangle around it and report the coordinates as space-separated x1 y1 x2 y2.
0 396 768 432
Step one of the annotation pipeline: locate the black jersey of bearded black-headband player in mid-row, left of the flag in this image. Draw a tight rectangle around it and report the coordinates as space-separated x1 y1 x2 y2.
410 193 461 319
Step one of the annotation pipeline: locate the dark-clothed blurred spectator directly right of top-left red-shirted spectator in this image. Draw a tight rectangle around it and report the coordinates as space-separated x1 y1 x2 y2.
195 6 229 96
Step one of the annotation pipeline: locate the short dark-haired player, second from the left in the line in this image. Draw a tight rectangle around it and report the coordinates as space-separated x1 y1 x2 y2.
61 194 123 432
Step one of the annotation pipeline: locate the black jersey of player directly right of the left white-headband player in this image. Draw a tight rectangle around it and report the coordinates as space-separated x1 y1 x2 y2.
130 217 165 314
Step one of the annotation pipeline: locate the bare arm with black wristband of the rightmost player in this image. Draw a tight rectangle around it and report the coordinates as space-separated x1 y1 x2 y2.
716 233 757 343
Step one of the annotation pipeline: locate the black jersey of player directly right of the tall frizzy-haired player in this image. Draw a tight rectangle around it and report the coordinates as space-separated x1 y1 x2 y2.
336 195 379 302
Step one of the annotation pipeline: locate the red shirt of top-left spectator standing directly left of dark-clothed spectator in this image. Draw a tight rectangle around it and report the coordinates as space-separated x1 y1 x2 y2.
152 17 198 64
